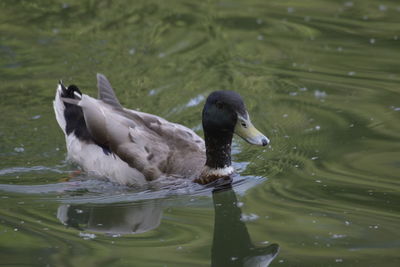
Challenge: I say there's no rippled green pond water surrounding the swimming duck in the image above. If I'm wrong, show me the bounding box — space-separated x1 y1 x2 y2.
0 0 400 266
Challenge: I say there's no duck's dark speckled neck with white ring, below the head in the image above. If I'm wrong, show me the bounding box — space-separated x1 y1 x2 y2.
196 132 233 184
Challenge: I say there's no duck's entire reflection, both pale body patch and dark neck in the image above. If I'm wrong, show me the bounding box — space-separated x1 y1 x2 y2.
57 183 279 267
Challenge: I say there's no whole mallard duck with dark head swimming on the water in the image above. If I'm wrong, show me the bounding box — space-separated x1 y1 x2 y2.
53 73 270 186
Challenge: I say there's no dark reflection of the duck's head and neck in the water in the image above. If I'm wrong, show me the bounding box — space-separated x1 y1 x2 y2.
211 184 279 267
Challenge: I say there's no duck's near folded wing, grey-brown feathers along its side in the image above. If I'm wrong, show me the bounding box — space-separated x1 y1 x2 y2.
67 94 170 180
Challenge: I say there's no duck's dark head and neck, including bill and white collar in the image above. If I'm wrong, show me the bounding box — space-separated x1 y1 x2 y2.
198 91 270 183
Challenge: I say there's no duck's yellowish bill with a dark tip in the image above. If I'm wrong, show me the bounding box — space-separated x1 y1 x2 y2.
235 117 270 146
